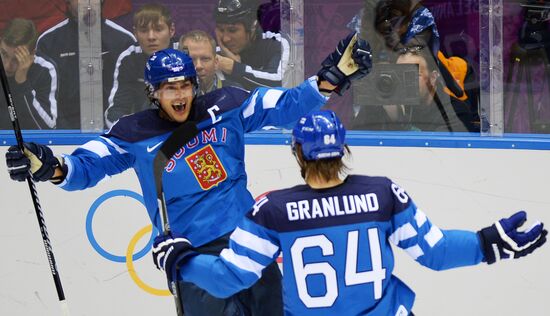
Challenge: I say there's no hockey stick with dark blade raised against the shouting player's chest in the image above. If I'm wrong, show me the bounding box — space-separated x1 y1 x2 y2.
153 121 198 316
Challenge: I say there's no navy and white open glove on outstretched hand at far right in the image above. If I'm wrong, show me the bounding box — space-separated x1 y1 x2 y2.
478 211 548 264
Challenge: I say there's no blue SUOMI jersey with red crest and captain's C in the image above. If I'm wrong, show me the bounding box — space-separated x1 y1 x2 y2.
60 77 327 246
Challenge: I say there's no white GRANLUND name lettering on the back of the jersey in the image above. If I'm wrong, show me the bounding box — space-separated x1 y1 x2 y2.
286 193 380 221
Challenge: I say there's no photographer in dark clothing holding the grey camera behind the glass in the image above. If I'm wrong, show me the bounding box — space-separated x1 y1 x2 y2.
353 46 479 132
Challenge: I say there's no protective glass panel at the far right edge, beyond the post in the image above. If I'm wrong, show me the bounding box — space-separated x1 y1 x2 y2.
502 0 550 134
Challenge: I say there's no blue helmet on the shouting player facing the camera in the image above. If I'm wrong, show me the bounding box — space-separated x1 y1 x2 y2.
144 48 198 91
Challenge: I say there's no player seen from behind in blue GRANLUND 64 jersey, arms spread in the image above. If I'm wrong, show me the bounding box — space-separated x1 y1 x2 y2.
153 111 548 316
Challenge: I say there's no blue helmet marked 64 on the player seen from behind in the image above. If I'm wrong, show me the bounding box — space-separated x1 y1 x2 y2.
292 110 346 160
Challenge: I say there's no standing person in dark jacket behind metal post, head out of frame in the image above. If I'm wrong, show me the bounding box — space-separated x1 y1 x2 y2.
37 0 135 129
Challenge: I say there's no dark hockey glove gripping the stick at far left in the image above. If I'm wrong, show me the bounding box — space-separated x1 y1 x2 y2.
6 143 60 181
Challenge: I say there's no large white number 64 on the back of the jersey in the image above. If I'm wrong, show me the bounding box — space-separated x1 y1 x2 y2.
290 228 386 308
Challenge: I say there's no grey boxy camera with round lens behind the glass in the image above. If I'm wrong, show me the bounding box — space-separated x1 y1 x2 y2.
353 64 420 106
